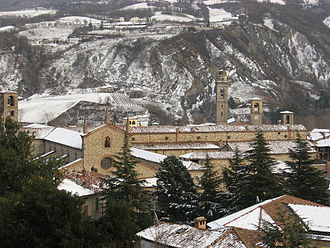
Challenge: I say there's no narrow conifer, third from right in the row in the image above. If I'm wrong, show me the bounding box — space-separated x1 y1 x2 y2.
222 148 248 214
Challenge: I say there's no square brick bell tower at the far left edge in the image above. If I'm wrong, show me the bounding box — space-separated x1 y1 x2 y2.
0 91 18 122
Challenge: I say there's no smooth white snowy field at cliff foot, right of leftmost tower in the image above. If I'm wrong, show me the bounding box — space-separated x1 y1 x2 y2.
18 93 136 123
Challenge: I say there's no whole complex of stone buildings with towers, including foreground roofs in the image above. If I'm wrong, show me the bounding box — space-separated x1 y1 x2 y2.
0 71 330 247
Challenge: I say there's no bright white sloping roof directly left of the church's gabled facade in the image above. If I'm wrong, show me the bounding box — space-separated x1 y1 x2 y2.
44 127 82 149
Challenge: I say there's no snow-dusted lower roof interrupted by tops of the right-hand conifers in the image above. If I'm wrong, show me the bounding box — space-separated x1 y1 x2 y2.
228 140 315 154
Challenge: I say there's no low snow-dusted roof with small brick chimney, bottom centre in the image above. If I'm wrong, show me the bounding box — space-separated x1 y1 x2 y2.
136 223 232 248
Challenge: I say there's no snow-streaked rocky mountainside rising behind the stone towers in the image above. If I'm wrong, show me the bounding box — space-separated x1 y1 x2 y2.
0 0 330 126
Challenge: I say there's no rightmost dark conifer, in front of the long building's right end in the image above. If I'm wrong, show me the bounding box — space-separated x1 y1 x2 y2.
284 136 329 204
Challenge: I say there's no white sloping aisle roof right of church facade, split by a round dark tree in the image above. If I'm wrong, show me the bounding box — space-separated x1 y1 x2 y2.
131 147 203 170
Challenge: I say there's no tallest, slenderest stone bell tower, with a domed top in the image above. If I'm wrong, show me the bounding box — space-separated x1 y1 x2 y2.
216 70 229 125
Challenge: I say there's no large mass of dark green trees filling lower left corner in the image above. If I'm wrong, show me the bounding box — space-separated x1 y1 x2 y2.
0 119 98 248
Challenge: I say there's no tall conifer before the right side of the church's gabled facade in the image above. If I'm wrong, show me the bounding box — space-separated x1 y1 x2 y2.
104 128 151 231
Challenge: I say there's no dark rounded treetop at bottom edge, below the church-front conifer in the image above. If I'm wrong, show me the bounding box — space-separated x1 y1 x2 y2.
97 200 139 248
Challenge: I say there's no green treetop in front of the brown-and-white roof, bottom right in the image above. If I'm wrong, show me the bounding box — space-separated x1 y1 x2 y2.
259 207 316 248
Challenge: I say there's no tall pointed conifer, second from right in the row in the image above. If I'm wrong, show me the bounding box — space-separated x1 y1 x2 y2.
242 132 282 207
